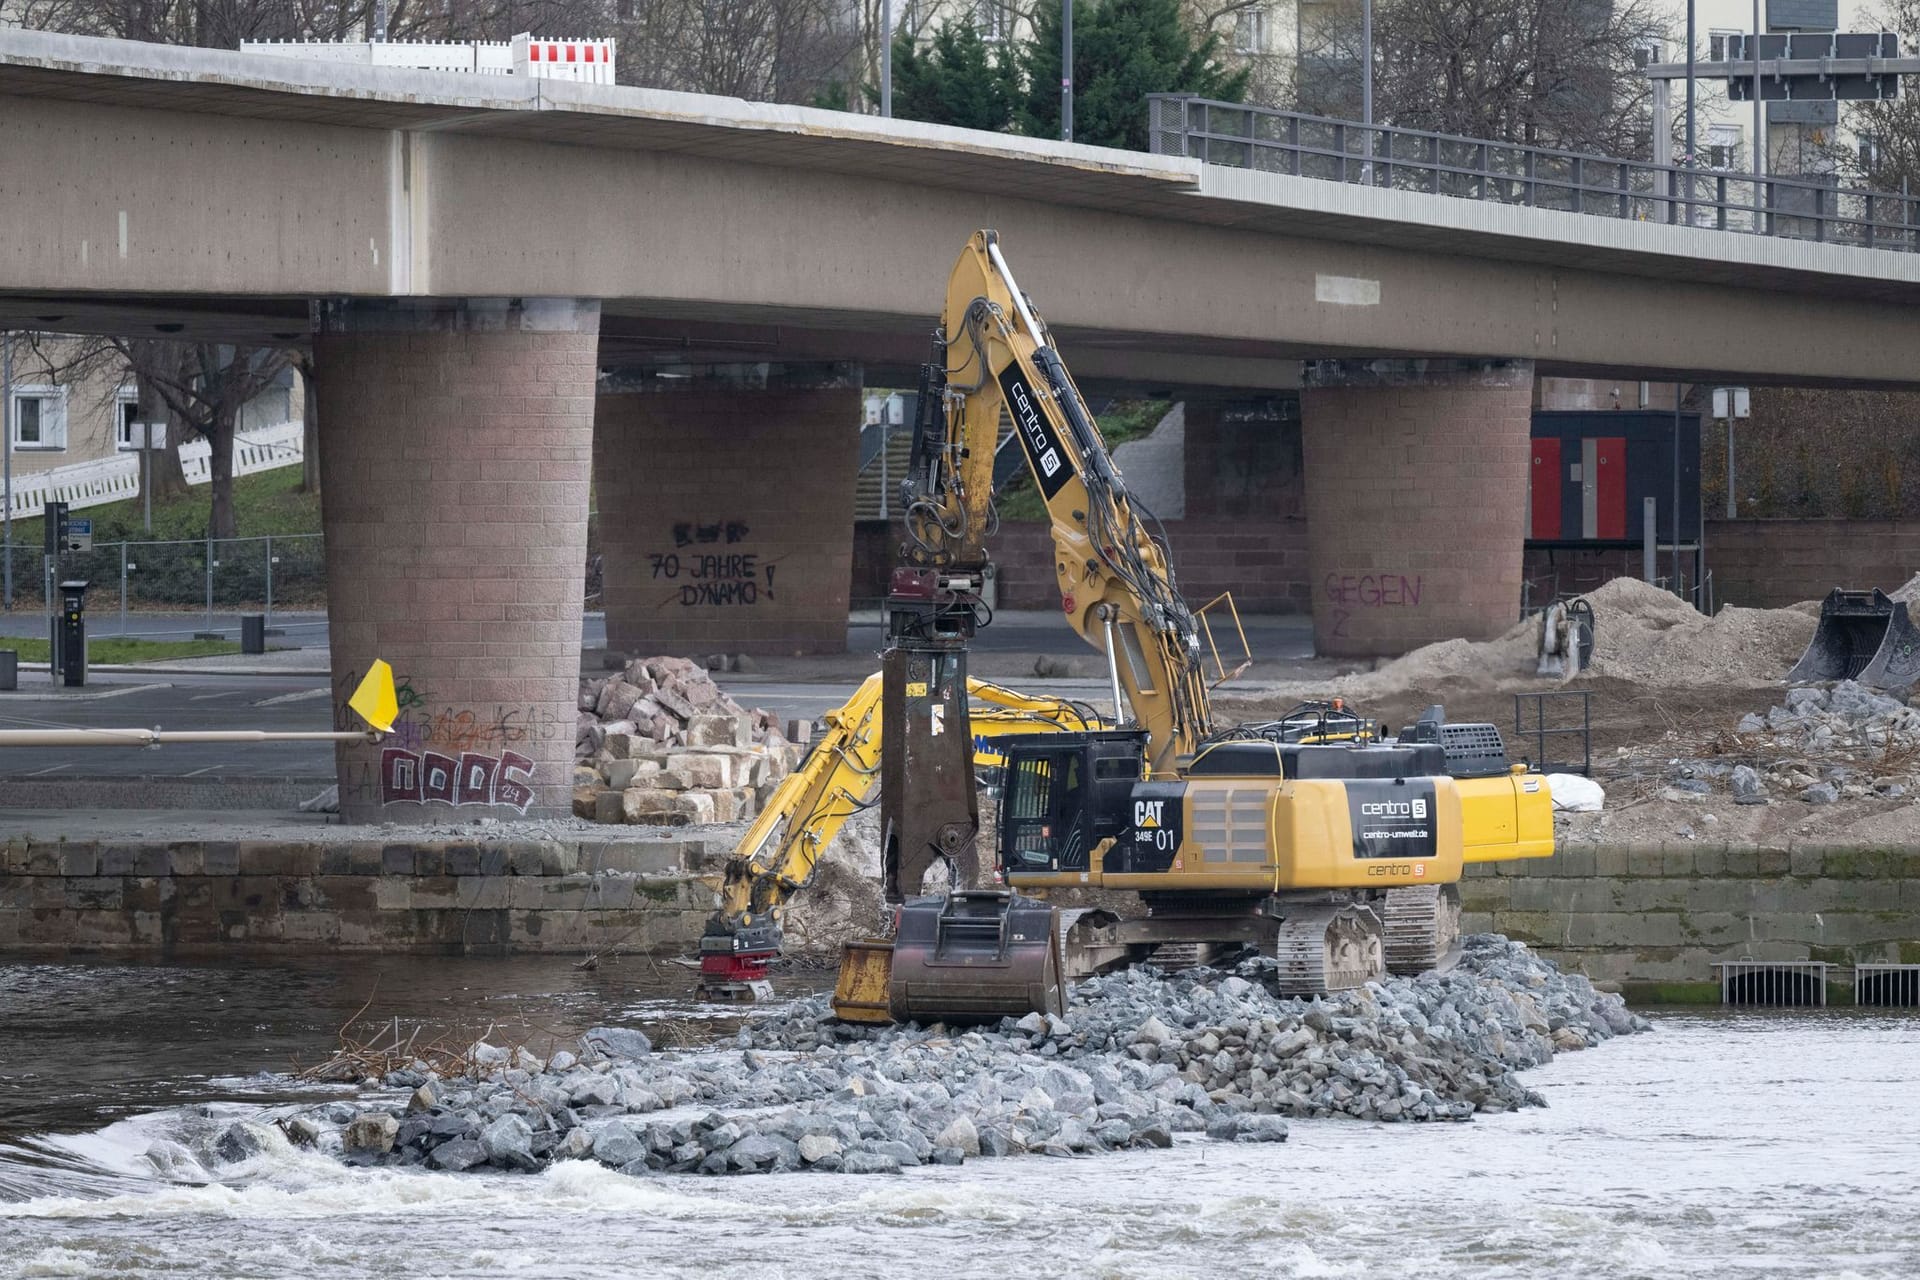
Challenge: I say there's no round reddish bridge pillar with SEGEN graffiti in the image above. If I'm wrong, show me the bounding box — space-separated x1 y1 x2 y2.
1300 359 1534 658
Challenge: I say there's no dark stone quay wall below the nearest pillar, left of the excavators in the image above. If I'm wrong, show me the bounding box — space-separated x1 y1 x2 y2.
0 831 735 952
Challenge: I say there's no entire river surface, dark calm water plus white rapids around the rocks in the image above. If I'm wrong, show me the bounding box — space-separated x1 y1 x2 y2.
0 958 1920 1280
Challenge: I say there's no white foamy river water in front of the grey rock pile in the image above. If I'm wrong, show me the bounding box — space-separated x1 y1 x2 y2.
0 1013 1920 1280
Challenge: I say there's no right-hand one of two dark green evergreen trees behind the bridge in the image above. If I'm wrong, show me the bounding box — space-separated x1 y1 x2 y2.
1020 0 1248 152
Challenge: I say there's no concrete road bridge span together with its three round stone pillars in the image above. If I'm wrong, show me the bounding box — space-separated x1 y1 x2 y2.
11 31 1920 821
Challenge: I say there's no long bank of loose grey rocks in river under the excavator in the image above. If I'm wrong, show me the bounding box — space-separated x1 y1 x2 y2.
263 935 1647 1174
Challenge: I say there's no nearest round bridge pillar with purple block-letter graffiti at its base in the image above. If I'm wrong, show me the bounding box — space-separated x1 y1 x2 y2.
313 297 599 823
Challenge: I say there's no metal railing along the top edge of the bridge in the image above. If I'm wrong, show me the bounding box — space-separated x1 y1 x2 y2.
1148 94 1920 253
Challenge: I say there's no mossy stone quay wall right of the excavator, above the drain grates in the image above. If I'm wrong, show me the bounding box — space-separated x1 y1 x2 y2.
1461 842 1920 984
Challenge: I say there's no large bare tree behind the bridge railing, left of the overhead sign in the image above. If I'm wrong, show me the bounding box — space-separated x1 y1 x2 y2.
1300 0 1667 155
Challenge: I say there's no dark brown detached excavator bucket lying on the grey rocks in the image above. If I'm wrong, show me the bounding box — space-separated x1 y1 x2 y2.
887 889 1066 1023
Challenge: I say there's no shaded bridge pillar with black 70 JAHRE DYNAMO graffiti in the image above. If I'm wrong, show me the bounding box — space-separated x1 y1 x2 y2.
593 363 862 656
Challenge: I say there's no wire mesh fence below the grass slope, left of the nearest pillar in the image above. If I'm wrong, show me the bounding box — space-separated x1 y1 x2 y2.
0 533 326 635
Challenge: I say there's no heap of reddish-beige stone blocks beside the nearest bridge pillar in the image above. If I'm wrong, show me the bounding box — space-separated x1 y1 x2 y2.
574 658 804 827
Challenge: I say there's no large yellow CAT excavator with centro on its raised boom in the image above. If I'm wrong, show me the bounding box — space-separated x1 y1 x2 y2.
698 230 1553 1021
